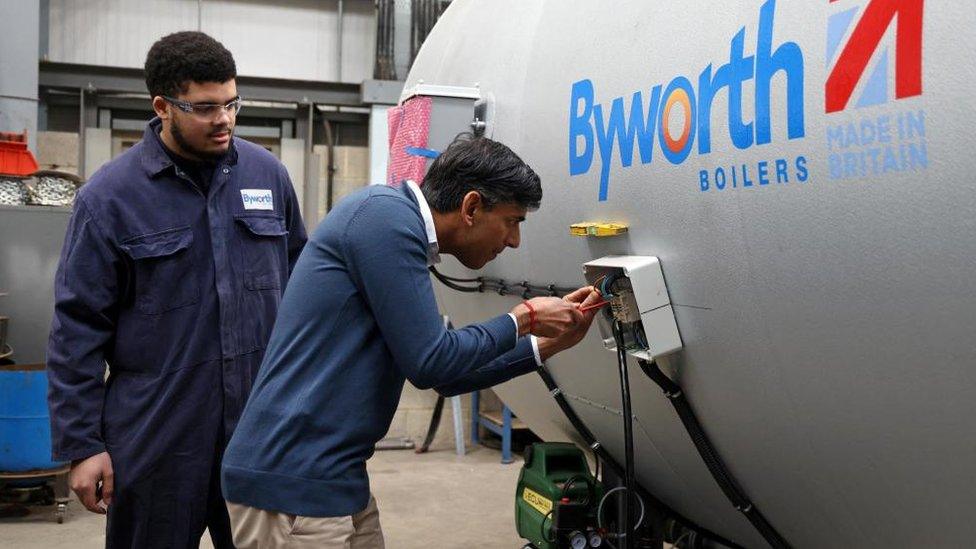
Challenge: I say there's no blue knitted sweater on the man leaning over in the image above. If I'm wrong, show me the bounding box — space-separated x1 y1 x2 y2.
221 185 536 517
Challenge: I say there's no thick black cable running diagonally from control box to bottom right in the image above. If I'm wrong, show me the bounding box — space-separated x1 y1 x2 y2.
637 359 790 549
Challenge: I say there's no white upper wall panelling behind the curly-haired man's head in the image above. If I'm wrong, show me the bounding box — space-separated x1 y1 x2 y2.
48 0 376 82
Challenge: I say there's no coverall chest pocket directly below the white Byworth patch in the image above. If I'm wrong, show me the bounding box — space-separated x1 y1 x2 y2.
235 213 288 290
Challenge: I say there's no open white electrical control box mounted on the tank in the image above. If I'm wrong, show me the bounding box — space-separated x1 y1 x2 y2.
583 255 682 360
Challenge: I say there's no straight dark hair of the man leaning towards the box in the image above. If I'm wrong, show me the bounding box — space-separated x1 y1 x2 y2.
421 134 542 213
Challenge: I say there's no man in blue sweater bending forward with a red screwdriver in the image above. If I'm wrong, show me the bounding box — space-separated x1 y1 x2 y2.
222 138 600 549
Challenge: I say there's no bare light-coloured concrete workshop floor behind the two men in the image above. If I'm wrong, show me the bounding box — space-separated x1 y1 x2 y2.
0 447 522 549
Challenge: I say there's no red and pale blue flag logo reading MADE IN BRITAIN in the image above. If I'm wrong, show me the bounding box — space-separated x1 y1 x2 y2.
824 0 928 180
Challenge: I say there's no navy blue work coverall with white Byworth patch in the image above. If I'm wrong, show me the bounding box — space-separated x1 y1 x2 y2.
47 119 306 549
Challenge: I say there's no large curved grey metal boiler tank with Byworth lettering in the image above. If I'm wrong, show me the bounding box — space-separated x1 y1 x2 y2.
407 0 976 547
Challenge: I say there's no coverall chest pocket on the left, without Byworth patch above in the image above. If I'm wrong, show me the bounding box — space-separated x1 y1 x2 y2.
120 227 200 315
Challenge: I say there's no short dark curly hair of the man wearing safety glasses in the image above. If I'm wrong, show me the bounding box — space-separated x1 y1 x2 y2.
146 31 237 97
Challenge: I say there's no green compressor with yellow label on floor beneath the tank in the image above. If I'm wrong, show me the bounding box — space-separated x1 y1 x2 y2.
515 442 606 549
